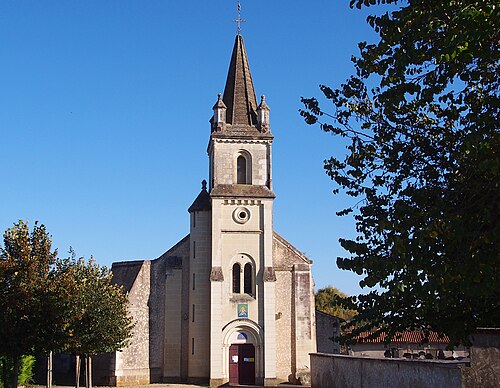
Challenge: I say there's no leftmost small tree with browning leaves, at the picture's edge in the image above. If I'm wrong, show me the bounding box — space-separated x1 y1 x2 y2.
0 221 57 387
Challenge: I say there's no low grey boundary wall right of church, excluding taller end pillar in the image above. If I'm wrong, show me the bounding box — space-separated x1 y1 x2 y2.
310 353 468 388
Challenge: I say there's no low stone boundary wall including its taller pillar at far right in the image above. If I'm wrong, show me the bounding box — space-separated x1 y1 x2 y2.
310 328 500 388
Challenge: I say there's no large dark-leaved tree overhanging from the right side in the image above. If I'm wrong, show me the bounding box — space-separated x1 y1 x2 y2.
301 0 500 343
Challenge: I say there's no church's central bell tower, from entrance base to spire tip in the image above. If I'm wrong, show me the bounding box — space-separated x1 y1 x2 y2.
208 33 276 386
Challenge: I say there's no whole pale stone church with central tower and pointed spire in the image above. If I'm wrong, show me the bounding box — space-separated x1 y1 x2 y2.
94 33 316 387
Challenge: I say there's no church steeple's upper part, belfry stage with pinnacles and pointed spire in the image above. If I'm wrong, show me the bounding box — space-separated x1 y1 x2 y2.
207 34 274 194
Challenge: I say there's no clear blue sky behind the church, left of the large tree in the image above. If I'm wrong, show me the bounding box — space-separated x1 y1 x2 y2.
0 0 380 294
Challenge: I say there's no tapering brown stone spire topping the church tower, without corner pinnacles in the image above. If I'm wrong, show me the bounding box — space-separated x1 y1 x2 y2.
223 35 258 127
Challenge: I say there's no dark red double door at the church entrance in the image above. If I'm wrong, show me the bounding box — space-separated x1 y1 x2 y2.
229 344 255 385
